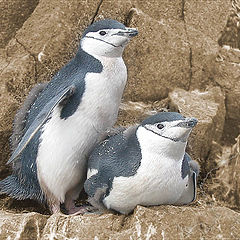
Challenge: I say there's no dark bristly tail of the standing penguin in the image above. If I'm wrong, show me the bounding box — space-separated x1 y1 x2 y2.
0 175 44 202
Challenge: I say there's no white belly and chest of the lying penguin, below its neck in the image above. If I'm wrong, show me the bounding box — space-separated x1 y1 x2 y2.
103 156 188 214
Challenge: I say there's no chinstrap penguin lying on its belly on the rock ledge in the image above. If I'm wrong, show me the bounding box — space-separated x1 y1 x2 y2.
84 112 199 214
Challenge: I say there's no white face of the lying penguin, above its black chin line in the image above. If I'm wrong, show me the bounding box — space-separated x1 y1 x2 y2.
144 119 196 143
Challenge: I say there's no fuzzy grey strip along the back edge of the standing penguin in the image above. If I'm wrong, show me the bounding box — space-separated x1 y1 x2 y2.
10 82 48 151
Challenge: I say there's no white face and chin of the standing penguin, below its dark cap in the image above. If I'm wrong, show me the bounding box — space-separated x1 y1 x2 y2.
81 28 137 57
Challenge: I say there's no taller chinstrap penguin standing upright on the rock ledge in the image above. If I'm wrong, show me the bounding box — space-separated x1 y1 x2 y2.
0 19 138 214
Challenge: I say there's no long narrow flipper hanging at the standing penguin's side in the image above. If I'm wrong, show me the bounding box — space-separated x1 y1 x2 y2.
7 85 76 164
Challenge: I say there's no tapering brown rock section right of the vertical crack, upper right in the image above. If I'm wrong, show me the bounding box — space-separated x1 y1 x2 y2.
183 0 231 90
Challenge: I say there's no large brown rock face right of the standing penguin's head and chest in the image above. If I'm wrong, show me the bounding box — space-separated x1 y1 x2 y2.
94 0 231 101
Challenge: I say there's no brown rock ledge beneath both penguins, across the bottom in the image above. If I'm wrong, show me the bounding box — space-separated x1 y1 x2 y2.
0 206 240 240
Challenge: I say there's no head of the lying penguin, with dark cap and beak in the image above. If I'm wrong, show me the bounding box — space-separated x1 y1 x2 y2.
141 112 198 143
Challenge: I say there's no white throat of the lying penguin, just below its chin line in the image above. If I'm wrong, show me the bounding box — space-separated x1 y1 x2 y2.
137 127 187 161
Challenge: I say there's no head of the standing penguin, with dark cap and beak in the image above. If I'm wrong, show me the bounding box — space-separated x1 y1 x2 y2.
80 19 138 57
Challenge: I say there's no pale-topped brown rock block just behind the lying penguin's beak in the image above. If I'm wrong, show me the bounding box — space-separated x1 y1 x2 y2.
169 87 225 174
